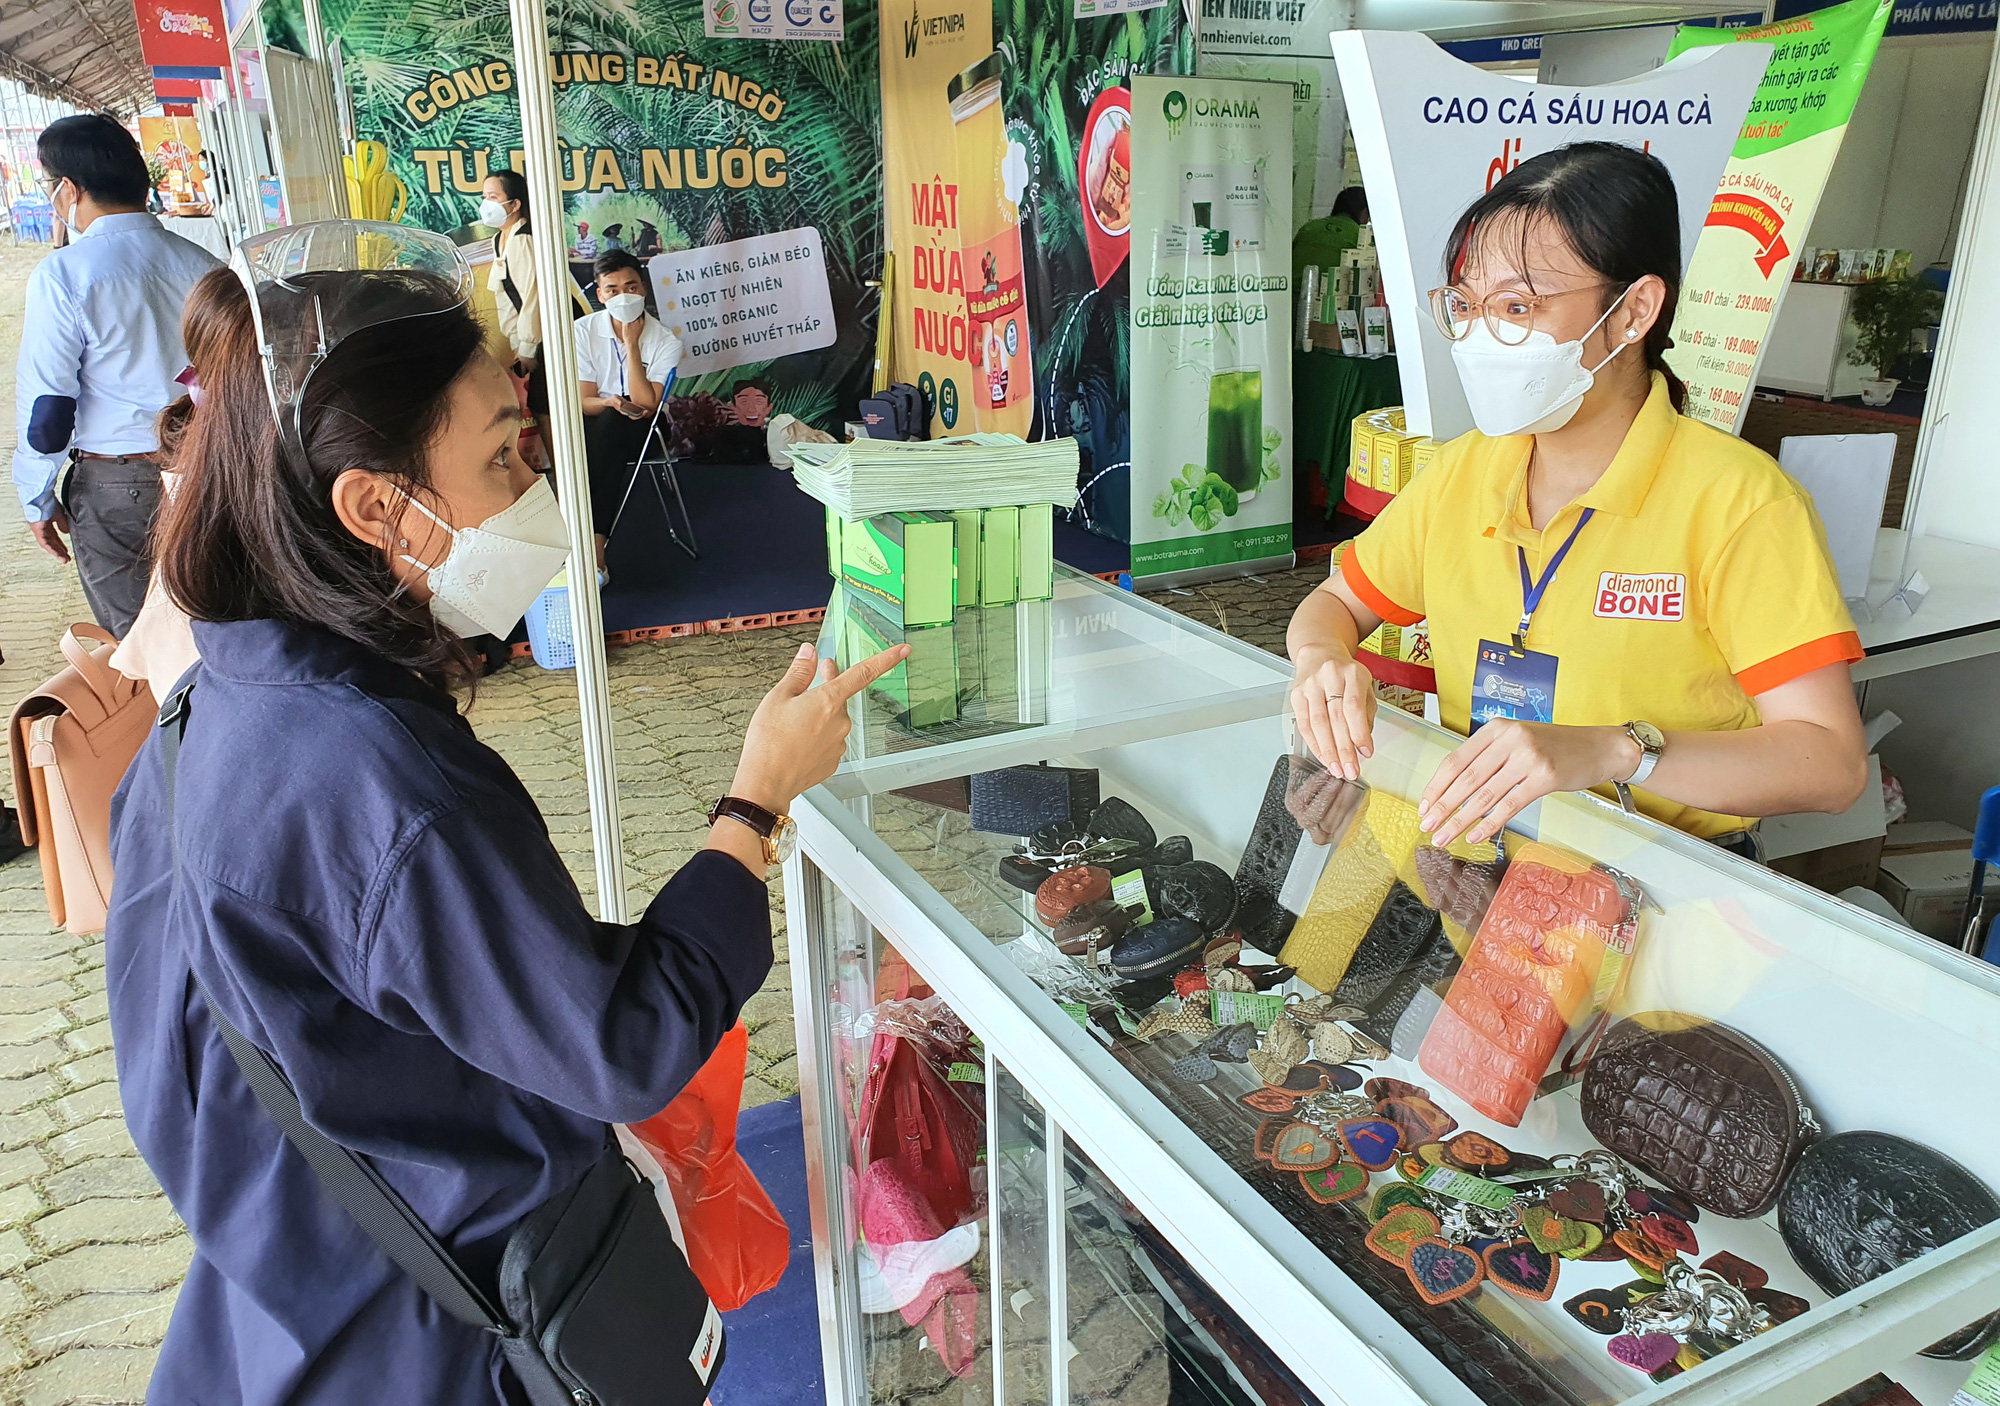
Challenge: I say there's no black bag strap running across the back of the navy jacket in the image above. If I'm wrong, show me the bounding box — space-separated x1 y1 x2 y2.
160 678 512 1336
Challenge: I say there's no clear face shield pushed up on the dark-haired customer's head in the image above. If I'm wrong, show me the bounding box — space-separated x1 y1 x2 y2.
230 220 472 464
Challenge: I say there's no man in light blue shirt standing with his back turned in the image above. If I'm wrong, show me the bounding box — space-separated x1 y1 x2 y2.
14 114 220 638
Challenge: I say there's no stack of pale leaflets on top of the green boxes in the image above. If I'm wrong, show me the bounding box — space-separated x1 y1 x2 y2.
790 434 1076 522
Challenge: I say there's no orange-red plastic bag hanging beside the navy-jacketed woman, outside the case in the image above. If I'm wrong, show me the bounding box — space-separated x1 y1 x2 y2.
632 1020 792 1312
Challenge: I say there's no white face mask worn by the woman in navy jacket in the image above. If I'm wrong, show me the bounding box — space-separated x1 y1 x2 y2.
402 478 570 638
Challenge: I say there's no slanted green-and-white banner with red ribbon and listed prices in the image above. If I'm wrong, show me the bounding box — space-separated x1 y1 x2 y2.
1666 0 1892 434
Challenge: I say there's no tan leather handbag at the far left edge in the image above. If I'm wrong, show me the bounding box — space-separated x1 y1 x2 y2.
8 624 156 934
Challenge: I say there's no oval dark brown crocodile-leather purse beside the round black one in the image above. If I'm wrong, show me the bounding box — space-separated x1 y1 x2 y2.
1582 1010 1820 1218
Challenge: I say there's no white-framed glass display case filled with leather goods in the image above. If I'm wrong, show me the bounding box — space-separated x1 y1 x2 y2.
786 572 2000 1406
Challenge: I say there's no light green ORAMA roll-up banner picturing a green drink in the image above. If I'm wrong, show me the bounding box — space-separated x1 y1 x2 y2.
1132 78 1292 584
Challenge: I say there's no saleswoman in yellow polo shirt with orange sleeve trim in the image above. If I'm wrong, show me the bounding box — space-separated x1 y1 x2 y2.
1288 142 1866 848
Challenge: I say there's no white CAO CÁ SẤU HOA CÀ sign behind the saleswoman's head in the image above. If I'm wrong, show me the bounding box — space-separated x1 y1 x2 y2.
1332 30 1770 444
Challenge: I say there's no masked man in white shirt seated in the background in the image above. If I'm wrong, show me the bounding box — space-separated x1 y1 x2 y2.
572 250 680 568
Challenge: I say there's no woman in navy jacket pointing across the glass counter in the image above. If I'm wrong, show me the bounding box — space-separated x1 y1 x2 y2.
104 256 900 1406
